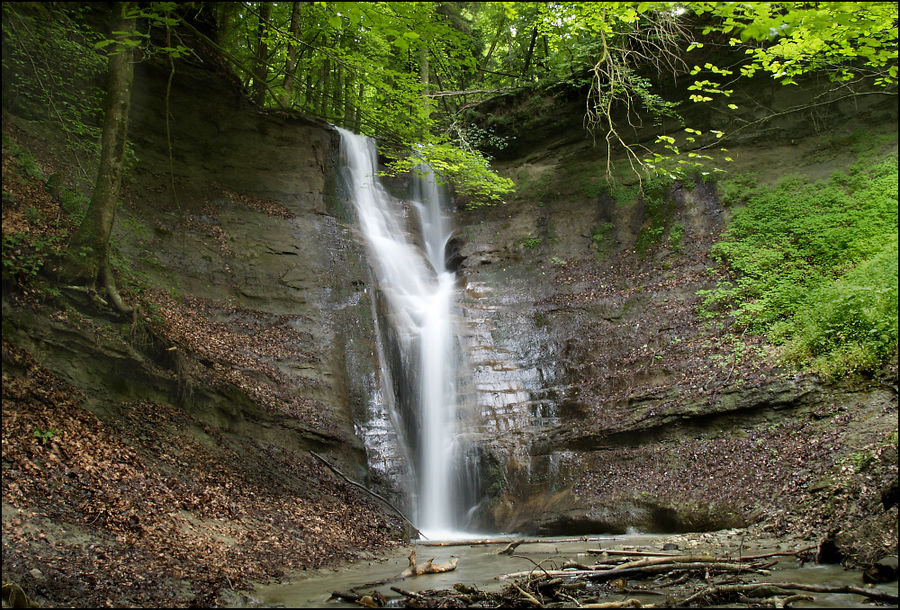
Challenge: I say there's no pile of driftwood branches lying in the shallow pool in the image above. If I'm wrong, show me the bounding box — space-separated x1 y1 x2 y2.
334 541 897 608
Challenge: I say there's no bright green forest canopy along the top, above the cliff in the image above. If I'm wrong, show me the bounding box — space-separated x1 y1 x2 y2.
3 2 897 205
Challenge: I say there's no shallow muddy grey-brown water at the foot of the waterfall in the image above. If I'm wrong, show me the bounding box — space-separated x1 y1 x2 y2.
243 530 897 608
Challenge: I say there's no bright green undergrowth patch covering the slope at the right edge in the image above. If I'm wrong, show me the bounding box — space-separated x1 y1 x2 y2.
698 147 898 377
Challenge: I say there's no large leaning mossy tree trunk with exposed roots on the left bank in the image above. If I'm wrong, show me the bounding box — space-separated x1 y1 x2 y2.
62 2 135 311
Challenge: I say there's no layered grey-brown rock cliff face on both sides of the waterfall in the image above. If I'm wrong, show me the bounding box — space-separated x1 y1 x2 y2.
118 54 896 560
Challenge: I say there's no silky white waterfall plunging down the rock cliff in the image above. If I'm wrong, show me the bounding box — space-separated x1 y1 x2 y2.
338 128 477 538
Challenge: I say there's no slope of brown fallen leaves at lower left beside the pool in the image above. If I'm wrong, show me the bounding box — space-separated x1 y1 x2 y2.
3 341 399 606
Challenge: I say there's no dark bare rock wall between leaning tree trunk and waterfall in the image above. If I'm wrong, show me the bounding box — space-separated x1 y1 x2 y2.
5 52 384 479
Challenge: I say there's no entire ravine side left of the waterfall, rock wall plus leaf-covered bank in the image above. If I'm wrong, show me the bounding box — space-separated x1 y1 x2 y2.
3 54 404 606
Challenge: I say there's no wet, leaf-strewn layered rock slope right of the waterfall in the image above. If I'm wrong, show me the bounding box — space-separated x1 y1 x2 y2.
460 86 897 563
